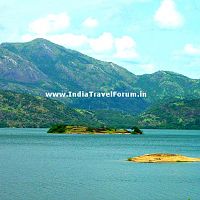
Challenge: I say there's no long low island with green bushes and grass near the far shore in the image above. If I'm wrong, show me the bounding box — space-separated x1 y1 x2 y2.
48 125 142 134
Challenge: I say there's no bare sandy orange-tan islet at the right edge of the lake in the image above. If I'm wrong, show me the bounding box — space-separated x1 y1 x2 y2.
128 153 200 163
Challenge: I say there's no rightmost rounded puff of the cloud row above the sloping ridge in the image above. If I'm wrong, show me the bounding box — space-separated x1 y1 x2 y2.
114 36 138 59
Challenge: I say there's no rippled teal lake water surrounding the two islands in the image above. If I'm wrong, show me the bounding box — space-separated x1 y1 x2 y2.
0 129 200 200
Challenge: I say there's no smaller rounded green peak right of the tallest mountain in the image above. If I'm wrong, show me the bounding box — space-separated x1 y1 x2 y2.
135 71 200 104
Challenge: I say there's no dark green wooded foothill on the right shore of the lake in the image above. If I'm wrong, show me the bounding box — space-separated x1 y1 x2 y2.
135 99 200 129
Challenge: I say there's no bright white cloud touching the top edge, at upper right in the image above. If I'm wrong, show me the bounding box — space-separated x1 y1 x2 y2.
154 0 183 28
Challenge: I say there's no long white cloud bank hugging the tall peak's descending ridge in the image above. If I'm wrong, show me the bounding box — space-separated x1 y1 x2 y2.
22 22 139 60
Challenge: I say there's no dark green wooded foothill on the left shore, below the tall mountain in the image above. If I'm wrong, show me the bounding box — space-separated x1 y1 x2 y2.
0 90 102 127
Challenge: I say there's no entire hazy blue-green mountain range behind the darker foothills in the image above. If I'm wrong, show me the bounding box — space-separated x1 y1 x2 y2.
0 39 200 114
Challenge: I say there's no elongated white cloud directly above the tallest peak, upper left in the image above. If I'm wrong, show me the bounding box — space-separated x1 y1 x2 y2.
29 13 70 35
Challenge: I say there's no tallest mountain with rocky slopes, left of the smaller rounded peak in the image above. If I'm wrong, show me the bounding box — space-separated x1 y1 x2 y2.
0 39 147 112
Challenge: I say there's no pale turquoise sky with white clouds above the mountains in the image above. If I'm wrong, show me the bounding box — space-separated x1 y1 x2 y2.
0 0 200 79
